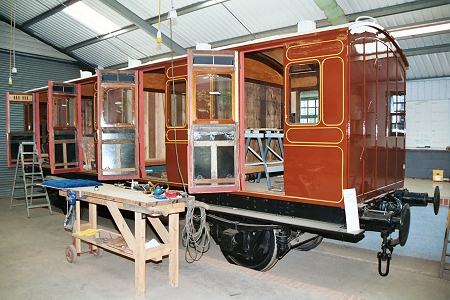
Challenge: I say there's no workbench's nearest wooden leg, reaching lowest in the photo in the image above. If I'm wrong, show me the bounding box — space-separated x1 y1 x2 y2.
134 212 146 296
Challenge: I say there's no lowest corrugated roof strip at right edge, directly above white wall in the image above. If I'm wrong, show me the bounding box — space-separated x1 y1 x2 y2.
407 52 450 79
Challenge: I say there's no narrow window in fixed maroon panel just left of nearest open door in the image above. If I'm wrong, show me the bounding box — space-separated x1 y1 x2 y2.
167 79 186 127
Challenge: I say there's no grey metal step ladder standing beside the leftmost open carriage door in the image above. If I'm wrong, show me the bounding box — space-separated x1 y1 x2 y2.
10 142 53 218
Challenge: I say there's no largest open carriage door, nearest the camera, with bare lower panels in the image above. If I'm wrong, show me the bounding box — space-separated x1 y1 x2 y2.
188 51 239 193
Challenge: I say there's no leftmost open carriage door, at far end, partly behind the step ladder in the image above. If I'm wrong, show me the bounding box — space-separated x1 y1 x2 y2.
6 93 33 167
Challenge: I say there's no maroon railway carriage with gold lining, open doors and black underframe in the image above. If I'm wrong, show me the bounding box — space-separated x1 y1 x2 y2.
7 22 439 275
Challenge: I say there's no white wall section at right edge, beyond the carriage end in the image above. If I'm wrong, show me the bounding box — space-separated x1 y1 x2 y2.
406 77 450 149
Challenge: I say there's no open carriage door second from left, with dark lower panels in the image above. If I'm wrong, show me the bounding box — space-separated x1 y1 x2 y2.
47 81 83 174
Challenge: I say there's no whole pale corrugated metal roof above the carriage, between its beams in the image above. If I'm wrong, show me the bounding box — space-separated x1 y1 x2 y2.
0 0 450 78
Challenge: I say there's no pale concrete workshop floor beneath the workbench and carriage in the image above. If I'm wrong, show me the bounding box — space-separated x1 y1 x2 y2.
0 179 450 300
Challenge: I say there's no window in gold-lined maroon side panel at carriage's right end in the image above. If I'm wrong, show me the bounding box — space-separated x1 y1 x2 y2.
289 62 320 124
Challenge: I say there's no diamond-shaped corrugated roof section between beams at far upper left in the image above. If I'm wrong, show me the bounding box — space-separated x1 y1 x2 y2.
30 12 97 47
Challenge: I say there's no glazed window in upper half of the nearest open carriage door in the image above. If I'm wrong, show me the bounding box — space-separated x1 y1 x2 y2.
195 74 233 120
